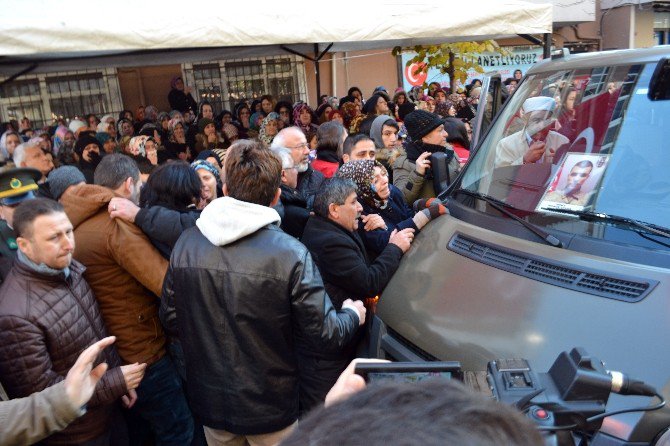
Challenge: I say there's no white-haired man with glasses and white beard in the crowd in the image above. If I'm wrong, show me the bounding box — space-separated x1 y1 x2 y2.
271 127 325 210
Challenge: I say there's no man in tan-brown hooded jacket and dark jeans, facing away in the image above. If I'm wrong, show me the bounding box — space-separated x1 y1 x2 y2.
61 154 193 445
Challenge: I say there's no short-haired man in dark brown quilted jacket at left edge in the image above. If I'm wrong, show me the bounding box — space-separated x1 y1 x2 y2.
0 198 146 445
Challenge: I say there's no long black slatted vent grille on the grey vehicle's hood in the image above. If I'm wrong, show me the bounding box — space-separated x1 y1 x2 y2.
447 234 658 302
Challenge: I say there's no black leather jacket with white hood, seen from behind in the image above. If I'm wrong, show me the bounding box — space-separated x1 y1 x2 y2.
163 197 358 435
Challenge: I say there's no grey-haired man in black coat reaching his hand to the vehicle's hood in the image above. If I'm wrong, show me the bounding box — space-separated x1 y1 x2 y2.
299 177 414 413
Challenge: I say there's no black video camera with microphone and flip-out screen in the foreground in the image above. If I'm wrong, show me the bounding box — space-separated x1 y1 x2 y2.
356 347 665 445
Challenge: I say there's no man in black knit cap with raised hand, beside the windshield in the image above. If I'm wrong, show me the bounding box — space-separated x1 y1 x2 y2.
393 110 460 204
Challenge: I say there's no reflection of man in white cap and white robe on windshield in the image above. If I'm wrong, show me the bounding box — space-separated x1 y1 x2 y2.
495 96 570 167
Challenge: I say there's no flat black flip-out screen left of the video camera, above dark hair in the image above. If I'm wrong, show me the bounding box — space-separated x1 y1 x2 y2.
355 361 462 383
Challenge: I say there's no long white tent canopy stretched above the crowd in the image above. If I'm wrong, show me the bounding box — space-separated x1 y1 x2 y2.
0 0 553 75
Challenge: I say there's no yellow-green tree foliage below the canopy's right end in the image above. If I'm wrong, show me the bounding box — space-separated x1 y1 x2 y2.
404 40 509 90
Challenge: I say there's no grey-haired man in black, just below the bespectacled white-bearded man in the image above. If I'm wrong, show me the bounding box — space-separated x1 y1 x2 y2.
272 148 309 240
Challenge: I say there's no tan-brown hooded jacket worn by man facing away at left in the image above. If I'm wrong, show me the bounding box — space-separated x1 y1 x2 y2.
61 184 167 365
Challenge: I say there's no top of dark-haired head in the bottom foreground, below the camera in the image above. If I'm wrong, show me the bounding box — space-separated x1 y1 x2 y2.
282 379 543 446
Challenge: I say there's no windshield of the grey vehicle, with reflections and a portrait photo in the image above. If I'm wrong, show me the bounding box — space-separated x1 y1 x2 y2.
460 63 670 247
